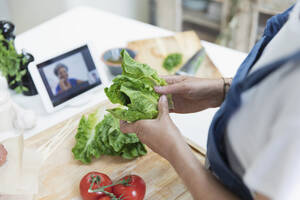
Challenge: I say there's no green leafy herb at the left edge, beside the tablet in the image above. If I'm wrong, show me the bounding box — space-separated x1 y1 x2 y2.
0 32 28 93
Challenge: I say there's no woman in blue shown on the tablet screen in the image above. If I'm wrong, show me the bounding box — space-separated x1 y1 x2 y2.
54 63 83 94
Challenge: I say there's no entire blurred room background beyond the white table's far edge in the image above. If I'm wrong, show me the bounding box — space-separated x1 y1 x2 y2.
0 0 296 52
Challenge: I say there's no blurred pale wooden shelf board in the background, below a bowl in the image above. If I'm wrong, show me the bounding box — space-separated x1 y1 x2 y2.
182 8 221 31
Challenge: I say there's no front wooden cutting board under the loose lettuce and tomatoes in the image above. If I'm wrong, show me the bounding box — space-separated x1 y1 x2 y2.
25 101 204 200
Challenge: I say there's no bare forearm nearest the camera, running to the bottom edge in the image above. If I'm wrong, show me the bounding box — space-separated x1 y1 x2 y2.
168 141 238 200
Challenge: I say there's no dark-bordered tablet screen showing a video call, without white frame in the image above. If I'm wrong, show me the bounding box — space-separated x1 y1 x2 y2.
37 45 101 107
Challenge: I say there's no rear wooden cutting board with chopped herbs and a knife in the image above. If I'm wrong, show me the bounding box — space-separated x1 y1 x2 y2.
127 31 222 78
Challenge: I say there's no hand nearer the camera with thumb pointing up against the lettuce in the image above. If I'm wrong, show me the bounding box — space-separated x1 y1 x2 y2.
120 95 186 160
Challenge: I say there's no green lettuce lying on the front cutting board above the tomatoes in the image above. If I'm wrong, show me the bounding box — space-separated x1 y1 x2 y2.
72 112 147 164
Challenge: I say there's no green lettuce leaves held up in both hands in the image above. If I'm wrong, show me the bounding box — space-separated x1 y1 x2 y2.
105 50 172 122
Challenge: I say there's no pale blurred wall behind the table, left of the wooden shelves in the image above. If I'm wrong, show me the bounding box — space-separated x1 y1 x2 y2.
4 0 150 33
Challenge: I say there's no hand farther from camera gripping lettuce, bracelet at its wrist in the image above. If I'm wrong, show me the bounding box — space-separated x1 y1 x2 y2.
155 76 224 113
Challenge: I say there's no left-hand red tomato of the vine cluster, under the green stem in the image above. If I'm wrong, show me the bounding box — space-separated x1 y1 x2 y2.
80 172 112 200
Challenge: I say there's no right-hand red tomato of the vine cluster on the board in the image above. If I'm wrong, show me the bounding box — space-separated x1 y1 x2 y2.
113 175 146 200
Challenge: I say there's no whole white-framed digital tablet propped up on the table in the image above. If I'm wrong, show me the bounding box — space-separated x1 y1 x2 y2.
29 44 107 112
